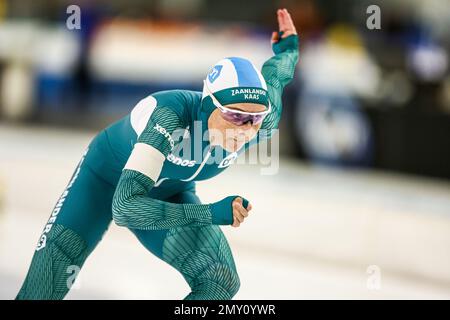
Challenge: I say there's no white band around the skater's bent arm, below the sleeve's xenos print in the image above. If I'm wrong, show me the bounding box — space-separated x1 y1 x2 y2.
124 142 166 182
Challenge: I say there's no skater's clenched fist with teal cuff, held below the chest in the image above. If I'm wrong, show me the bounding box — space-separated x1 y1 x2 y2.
210 196 252 227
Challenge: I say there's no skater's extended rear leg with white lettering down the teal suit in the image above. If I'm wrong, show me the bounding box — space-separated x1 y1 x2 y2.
16 150 114 300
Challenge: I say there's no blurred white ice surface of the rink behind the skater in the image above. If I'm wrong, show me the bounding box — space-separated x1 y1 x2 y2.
0 125 450 299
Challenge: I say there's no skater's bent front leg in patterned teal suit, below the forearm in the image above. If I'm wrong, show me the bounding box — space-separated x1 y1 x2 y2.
133 191 240 300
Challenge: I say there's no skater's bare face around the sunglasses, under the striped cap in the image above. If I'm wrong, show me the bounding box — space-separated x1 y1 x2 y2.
208 103 266 152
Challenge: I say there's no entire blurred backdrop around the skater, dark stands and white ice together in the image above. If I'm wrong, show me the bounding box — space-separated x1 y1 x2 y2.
0 0 450 299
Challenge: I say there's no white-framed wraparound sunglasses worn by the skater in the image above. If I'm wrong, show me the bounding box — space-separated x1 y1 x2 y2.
203 80 272 126
